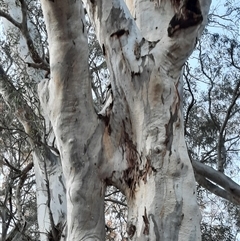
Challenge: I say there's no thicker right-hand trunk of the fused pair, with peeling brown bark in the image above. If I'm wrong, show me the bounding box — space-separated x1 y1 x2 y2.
85 1 210 240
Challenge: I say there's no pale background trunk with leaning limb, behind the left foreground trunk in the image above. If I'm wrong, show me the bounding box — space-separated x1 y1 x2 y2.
0 0 66 241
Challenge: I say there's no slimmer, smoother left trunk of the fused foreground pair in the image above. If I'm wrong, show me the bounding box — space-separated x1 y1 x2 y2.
39 1 105 240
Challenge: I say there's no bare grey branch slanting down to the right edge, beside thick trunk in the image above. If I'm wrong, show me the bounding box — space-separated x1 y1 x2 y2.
192 160 240 204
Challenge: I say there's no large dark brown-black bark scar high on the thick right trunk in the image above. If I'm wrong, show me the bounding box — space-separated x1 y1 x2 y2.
167 0 203 37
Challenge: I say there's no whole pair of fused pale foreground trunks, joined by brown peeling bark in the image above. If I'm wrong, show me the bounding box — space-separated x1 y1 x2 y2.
42 0 210 241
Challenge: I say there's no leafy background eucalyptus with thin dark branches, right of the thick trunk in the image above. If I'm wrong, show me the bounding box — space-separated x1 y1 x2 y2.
184 1 240 240
